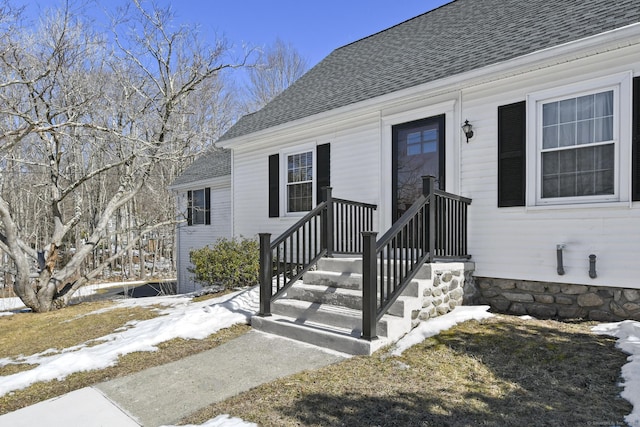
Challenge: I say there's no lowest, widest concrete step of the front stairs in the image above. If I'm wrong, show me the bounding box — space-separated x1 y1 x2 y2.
251 315 391 355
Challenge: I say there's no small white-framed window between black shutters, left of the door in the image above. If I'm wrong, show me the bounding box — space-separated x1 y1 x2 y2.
281 147 316 214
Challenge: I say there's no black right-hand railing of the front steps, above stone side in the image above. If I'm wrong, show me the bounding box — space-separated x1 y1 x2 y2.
362 177 471 340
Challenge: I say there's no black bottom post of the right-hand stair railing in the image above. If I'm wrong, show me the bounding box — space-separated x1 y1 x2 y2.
362 231 378 341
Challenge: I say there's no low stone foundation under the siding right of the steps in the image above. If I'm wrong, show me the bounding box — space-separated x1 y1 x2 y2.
472 277 640 321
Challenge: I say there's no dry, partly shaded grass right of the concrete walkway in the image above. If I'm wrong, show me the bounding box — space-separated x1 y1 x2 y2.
183 316 632 427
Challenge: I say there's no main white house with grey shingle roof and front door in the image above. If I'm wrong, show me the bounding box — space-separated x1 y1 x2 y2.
218 0 640 328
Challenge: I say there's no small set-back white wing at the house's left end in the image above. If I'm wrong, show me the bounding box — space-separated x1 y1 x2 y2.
170 150 231 293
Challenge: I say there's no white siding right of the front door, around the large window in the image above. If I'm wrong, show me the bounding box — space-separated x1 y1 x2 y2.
460 47 640 289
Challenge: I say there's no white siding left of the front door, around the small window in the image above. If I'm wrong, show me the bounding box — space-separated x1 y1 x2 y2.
233 116 380 238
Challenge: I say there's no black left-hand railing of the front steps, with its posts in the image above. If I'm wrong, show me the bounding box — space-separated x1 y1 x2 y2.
259 187 377 316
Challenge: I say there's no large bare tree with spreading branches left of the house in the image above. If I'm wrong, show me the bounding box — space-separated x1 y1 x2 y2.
0 0 243 312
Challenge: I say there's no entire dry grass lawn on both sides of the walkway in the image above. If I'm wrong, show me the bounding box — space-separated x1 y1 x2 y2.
0 302 632 427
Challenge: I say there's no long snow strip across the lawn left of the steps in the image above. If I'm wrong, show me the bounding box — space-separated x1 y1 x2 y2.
0 287 259 396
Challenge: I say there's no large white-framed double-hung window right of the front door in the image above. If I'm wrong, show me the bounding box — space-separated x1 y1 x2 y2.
527 74 631 206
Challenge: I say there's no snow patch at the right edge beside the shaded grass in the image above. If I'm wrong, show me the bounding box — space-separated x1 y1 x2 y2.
592 320 640 427
